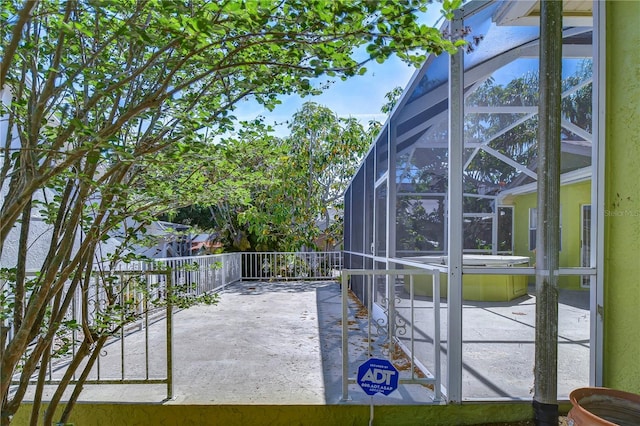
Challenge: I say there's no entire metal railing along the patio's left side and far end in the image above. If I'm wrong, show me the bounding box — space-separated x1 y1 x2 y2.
6 252 342 398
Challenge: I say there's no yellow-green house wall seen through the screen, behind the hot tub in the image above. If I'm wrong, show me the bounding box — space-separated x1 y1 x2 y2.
505 181 591 289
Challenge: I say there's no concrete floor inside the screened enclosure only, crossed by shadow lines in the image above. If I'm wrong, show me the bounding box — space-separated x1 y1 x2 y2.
396 287 590 400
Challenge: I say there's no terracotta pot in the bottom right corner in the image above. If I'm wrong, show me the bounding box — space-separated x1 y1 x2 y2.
568 387 640 426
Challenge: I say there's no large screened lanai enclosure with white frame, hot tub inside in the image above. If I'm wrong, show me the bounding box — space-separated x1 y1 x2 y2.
344 1 601 401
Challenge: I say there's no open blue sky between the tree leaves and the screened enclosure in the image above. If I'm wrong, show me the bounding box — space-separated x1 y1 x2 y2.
234 2 441 136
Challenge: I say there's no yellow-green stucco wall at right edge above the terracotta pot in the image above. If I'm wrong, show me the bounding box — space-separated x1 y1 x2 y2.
603 1 640 393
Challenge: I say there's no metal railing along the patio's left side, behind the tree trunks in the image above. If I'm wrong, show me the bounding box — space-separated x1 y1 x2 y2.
5 253 242 398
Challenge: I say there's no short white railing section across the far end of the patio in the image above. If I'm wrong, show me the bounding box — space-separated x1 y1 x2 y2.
242 251 342 281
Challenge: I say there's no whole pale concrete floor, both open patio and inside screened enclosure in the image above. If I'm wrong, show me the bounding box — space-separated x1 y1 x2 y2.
27 282 589 405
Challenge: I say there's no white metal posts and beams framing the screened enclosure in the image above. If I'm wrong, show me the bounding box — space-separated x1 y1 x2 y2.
342 0 606 402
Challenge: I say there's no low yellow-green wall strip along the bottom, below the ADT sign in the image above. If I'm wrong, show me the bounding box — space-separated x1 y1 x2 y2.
12 402 536 426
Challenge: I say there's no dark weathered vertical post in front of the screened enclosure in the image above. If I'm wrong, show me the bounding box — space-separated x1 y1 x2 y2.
533 0 562 425
